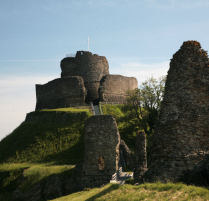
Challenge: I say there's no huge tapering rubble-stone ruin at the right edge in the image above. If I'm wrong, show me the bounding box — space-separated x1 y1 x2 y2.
144 41 209 181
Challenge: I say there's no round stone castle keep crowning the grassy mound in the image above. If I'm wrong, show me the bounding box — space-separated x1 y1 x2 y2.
36 51 138 110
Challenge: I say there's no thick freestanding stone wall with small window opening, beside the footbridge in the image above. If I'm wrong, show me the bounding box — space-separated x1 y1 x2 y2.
67 115 120 192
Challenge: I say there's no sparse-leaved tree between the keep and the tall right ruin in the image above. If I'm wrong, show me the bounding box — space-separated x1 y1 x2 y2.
124 76 166 135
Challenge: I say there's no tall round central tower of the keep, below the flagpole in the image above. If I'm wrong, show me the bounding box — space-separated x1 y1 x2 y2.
60 51 109 102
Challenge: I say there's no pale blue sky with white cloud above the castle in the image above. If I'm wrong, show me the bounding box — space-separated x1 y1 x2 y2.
0 0 209 139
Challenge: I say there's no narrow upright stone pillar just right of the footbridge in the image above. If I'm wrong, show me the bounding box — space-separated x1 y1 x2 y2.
134 131 147 183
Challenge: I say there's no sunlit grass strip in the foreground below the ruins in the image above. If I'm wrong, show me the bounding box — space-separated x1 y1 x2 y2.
53 182 209 201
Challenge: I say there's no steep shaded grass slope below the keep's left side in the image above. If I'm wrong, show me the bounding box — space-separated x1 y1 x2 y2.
0 108 92 164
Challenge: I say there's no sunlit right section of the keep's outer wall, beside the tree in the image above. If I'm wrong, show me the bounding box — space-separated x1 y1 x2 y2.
99 75 138 104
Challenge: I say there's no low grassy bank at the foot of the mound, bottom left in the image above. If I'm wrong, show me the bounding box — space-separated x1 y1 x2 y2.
0 163 74 201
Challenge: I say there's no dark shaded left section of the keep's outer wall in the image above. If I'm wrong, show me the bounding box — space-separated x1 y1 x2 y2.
36 76 86 110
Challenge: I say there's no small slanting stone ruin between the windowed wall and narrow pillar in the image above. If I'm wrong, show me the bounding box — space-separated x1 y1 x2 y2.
120 140 135 170
